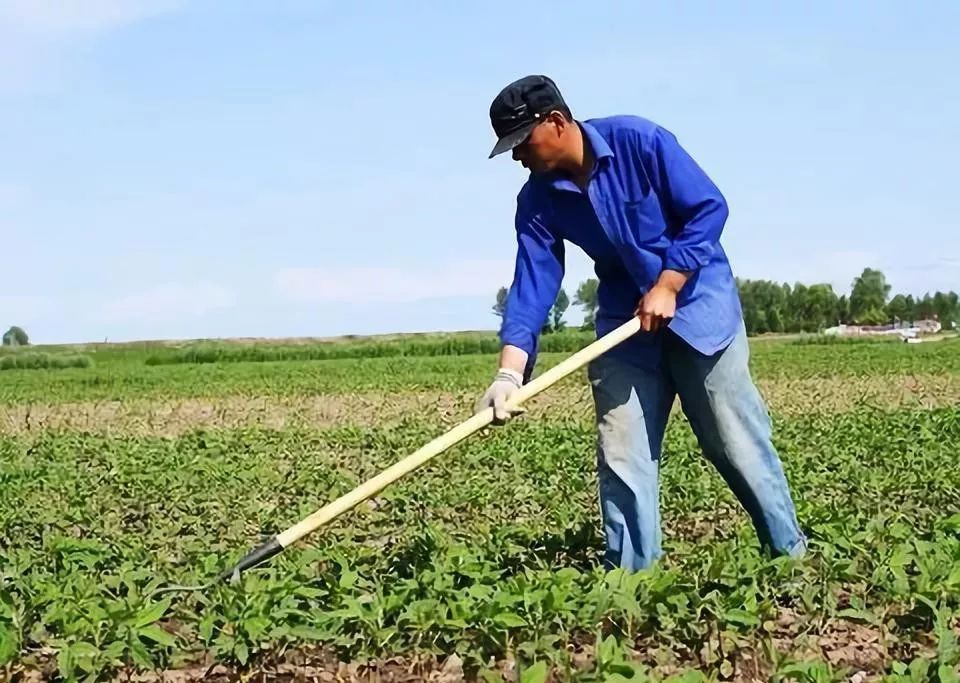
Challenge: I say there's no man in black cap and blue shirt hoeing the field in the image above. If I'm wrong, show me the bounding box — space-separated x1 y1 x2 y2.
476 76 806 571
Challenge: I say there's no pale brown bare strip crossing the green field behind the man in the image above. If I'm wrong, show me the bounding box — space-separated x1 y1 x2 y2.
0 374 960 436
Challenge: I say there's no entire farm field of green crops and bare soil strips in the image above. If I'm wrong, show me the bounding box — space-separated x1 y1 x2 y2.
0 340 960 683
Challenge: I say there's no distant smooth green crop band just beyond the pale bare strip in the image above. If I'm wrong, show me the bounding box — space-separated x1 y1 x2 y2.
0 341 960 404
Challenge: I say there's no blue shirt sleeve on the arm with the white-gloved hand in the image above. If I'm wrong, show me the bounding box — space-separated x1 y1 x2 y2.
500 190 564 378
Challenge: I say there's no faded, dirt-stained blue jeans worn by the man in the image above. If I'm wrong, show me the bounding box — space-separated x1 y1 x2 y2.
588 327 806 571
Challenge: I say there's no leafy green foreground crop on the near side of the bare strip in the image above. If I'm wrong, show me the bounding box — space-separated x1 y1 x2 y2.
0 409 960 680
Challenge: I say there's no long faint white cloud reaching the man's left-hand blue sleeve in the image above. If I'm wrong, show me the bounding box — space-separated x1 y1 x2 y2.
274 259 513 304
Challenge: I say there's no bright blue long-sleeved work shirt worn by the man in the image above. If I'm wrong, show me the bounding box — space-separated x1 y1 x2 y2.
500 116 743 379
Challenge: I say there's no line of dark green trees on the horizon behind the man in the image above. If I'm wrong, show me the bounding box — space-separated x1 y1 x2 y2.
493 268 960 335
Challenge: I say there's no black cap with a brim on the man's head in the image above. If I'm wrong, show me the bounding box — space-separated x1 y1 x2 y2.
487 75 566 159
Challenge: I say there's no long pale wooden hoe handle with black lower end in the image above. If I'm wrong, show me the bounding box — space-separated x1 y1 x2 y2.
221 317 640 580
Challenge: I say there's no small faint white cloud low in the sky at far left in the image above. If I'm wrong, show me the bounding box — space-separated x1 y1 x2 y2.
103 282 236 322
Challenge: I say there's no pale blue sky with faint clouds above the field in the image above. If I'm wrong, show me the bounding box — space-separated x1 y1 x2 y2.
0 0 960 343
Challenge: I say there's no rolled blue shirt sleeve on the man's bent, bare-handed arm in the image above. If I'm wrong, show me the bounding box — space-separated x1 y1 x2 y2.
647 127 729 272
